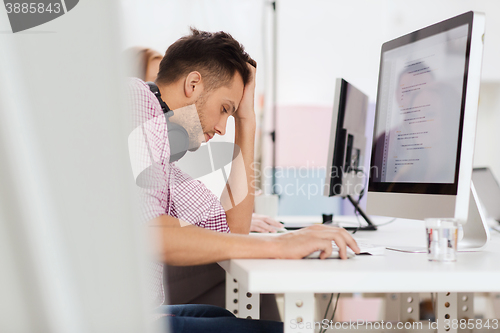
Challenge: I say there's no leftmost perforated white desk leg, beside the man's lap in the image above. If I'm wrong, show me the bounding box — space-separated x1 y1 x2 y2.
226 272 260 319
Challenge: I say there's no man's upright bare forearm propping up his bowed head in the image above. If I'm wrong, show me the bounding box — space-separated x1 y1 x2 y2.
221 118 255 234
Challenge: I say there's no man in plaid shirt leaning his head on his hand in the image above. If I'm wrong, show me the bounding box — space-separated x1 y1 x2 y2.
130 29 359 332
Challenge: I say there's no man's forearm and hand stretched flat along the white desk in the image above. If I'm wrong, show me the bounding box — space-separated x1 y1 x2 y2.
148 215 359 266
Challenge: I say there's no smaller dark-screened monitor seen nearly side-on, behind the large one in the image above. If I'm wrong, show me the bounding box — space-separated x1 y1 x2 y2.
323 78 376 230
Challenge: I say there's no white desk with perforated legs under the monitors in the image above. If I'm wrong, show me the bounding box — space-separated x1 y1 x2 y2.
219 219 500 333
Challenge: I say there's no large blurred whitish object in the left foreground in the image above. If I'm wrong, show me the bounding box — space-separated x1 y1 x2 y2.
0 0 158 333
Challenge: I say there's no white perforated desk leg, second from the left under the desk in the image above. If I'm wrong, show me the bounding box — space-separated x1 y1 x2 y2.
284 293 314 333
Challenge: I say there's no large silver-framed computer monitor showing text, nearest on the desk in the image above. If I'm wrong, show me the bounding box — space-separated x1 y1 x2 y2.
367 12 488 247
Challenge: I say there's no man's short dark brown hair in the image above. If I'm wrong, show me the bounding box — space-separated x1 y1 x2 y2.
156 28 256 90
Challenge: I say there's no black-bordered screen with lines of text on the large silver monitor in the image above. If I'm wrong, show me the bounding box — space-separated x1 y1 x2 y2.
370 16 471 194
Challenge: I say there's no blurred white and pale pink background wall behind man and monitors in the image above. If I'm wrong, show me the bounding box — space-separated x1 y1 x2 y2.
122 0 500 213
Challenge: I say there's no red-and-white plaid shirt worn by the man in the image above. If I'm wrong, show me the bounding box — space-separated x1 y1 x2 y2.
128 79 230 305
